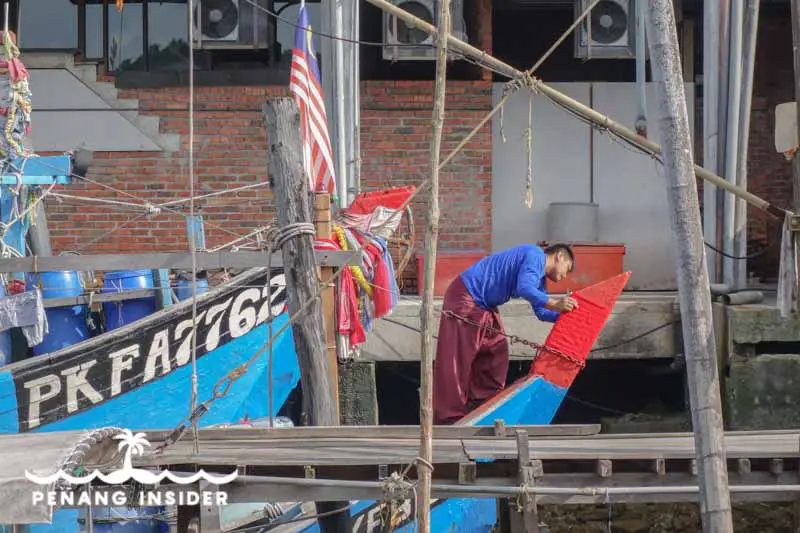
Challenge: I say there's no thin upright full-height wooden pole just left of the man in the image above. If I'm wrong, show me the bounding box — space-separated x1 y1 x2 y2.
417 0 450 533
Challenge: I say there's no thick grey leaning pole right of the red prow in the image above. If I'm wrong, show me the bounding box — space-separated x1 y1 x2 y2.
647 0 733 533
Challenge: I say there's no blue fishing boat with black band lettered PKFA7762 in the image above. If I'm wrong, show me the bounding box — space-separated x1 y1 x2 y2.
0 268 300 533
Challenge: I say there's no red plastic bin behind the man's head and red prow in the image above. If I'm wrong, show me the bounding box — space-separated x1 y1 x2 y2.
539 242 625 294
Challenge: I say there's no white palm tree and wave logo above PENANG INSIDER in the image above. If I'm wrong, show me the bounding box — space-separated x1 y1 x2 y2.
25 429 239 485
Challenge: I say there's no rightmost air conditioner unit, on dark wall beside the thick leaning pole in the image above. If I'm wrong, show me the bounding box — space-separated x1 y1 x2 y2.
574 0 636 59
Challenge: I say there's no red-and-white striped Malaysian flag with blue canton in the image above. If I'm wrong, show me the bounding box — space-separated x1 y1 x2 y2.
289 4 336 193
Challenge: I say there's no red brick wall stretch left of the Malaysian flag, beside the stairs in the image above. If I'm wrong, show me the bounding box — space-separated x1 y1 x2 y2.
47 87 284 253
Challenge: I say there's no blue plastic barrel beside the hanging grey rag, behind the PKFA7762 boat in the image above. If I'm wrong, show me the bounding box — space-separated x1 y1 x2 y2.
25 271 89 355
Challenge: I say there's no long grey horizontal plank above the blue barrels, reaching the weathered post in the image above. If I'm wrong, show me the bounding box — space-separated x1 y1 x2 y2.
0 251 352 273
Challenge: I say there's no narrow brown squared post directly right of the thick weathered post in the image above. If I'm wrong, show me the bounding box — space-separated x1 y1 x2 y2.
314 193 340 421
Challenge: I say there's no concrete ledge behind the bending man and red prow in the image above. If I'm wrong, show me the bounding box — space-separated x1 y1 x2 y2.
361 293 683 362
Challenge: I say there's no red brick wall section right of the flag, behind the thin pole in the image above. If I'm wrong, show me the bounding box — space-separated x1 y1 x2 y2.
361 81 492 289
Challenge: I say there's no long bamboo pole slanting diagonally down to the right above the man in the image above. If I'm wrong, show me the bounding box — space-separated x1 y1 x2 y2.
367 0 787 220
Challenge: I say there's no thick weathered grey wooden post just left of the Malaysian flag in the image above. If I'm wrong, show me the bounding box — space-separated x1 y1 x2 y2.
264 98 351 533
